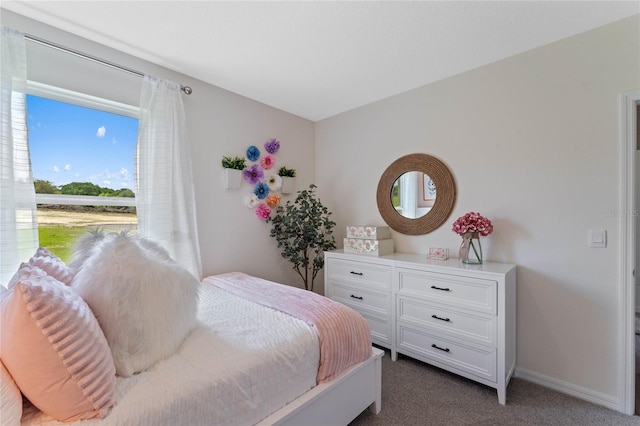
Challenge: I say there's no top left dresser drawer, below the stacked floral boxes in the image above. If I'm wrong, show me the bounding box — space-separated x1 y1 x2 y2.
327 259 391 291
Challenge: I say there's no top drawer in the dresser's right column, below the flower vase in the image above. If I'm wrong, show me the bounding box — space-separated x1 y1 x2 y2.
398 268 498 315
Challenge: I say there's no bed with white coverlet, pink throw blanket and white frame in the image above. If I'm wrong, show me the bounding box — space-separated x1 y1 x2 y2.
12 273 383 426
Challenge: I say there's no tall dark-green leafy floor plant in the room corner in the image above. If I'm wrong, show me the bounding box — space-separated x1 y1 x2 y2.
267 184 336 291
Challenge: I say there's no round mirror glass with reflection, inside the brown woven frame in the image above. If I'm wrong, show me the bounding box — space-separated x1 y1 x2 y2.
391 171 436 219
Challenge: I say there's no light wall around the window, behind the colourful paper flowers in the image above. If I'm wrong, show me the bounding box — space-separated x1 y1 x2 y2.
2 9 315 286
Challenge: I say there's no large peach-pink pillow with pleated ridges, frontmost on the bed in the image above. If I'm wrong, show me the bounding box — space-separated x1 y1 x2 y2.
0 266 116 421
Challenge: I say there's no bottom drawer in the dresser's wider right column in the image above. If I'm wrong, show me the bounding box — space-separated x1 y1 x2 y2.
397 325 497 382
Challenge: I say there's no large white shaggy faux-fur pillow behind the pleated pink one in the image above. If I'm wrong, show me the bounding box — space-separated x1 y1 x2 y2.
71 233 199 377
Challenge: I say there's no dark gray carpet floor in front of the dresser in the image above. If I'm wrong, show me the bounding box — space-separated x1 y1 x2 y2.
350 350 640 426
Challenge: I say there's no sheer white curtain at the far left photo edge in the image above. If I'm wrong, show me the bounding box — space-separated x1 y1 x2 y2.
0 27 38 286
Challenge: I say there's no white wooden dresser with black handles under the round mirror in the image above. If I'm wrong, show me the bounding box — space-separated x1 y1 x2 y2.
325 250 516 404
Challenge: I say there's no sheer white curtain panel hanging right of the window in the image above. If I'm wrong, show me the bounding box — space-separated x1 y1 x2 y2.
135 76 202 279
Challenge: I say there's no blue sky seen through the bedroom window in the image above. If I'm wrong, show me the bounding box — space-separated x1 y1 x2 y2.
27 95 138 190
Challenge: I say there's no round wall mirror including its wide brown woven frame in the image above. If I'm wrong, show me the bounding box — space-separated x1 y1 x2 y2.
377 154 456 235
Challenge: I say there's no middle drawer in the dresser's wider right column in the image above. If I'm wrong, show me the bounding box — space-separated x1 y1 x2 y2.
396 296 498 347
